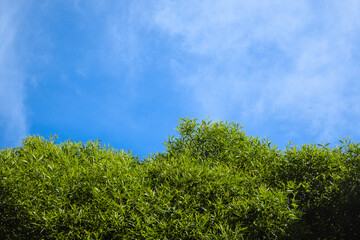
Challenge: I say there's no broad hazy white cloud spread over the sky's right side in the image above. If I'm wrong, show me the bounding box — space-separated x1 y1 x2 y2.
154 0 360 144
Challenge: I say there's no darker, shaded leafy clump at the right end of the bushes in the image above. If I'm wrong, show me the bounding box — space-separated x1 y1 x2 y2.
274 140 360 239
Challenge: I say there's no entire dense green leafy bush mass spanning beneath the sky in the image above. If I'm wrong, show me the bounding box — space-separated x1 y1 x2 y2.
0 119 360 239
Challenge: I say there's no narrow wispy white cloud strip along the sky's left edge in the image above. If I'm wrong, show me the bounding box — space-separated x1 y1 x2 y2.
0 0 28 147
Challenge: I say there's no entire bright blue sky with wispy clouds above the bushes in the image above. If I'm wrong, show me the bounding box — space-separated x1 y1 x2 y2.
0 0 360 156
